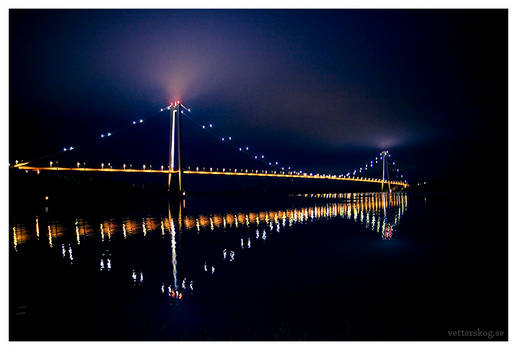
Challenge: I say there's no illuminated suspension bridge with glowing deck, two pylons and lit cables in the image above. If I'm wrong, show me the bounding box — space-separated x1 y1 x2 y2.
13 101 409 191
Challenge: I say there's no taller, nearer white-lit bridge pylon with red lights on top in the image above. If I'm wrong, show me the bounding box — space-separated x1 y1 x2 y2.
167 101 184 195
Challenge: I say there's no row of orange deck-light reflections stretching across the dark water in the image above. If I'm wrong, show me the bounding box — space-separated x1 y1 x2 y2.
15 194 407 245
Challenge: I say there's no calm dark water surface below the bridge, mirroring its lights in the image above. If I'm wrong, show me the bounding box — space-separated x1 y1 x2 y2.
10 193 507 340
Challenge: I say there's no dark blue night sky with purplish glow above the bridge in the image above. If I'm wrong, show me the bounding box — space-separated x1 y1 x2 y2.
9 10 508 180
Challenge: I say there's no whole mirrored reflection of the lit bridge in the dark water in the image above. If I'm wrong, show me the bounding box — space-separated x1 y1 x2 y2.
11 192 408 300
